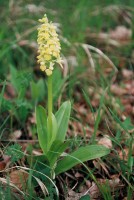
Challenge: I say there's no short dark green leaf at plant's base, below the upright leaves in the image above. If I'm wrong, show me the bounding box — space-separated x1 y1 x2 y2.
47 140 70 167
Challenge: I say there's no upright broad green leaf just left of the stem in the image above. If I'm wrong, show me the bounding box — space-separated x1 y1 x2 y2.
36 106 48 154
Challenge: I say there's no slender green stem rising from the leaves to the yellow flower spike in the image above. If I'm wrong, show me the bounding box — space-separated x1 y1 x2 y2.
48 75 53 134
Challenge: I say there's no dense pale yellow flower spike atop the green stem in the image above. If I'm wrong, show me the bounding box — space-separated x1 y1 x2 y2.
37 15 61 76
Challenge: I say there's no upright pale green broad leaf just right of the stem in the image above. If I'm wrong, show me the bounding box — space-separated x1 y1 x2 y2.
55 101 71 142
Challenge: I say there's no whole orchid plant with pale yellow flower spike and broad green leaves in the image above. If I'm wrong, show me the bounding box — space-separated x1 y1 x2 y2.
36 15 109 178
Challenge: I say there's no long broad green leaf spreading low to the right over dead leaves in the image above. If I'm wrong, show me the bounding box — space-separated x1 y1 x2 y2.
55 145 110 175
